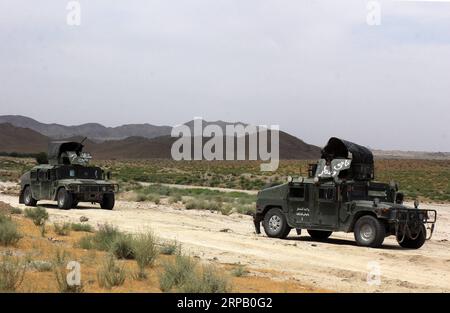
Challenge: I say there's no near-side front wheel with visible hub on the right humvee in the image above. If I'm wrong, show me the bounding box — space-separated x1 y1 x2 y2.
354 215 386 248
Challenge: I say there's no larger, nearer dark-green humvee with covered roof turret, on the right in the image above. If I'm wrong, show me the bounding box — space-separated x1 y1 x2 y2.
254 138 437 249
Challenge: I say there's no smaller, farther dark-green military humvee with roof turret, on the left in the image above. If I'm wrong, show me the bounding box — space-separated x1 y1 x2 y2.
19 142 119 210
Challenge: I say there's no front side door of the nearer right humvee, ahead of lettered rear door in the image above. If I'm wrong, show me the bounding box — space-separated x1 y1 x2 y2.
317 186 339 227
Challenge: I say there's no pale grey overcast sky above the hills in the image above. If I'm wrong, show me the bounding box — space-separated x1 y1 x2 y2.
0 0 450 151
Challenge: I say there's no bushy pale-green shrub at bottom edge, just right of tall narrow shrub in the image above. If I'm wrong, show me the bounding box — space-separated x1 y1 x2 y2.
159 254 197 292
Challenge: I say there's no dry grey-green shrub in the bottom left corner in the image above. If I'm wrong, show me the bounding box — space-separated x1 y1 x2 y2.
0 255 25 292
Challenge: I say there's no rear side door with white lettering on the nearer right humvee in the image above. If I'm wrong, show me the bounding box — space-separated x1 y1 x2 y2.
288 184 311 225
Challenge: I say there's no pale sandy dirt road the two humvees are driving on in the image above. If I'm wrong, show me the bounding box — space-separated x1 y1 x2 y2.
0 188 450 292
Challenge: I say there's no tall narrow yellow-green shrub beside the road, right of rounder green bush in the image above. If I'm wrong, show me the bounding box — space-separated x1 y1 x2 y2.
133 232 158 279
